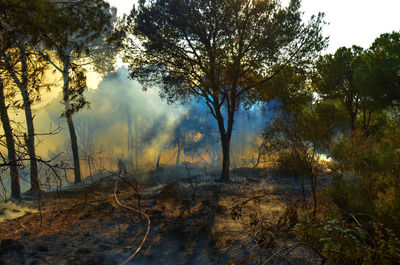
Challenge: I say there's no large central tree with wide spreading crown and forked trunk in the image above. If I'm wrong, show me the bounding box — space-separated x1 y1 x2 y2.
125 0 325 181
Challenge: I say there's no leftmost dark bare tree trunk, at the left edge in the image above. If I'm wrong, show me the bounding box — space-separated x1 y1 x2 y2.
0 80 21 200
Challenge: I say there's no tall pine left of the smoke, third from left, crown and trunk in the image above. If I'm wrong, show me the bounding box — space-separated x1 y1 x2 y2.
37 0 118 183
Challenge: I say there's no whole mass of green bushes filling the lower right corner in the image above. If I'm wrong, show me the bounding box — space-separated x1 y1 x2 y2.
297 113 400 264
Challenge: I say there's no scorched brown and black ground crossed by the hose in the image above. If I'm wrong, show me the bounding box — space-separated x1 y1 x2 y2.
0 169 324 265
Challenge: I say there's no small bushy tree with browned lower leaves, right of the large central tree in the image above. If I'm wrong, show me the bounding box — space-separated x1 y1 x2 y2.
263 94 342 214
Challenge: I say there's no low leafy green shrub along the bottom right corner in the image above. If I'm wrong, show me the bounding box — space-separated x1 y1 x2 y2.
296 218 400 265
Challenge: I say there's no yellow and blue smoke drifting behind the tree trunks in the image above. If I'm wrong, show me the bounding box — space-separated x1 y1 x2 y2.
3 68 280 194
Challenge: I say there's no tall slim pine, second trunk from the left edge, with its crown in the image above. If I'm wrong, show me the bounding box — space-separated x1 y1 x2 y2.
0 0 48 191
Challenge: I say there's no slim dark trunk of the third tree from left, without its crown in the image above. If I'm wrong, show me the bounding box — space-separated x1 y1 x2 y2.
63 55 82 183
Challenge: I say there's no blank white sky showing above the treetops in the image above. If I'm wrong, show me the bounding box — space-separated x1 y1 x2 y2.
108 0 400 53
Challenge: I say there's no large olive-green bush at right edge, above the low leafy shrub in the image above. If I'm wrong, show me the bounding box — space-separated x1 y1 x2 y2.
325 121 400 227
